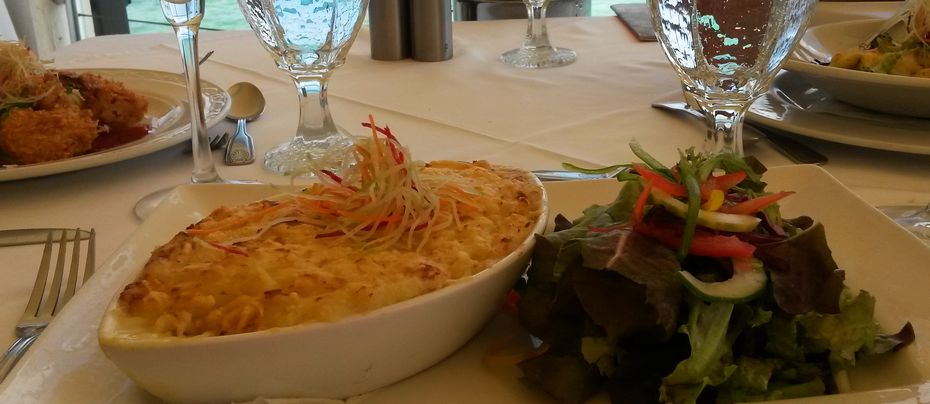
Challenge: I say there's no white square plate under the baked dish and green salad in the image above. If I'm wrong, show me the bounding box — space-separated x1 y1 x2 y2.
0 166 930 404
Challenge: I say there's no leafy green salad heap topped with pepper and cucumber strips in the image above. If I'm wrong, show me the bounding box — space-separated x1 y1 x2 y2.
515 143 914 403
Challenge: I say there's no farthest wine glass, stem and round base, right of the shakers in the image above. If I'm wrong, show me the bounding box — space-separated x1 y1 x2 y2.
501 0 575 69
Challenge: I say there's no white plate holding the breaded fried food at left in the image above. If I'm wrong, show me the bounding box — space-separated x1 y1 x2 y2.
0 69 231 181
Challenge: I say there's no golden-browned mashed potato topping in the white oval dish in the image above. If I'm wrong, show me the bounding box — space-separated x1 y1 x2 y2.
119 120 543 336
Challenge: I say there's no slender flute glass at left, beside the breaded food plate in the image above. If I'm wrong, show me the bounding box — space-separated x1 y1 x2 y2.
133 0 226 219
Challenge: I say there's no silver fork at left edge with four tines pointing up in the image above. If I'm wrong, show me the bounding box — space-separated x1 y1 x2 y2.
0 229 95 382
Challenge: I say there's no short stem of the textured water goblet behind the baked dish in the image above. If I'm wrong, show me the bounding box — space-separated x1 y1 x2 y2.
294 73 338 140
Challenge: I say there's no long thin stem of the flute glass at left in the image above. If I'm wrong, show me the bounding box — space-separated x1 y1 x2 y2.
174 25 220 184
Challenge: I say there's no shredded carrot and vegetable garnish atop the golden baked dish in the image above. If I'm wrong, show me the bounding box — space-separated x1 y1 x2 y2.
186 116 480 254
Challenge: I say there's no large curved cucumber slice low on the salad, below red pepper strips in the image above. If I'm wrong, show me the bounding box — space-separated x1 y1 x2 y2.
678 258 769 303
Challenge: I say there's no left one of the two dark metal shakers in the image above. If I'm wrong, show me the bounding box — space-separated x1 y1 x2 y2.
368 0 410 60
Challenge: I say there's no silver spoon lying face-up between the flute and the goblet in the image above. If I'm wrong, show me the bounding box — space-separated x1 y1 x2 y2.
223 82 265 166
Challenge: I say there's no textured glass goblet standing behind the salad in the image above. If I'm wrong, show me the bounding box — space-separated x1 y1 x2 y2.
649 0 817 155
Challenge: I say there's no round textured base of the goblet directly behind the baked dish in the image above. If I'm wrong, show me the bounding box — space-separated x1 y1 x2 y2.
265 131 355 177
